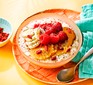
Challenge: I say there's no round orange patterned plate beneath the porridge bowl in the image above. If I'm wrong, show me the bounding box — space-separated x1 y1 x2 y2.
13 9 86 84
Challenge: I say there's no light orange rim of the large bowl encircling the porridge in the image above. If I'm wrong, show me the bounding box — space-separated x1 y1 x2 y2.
16 12 82 68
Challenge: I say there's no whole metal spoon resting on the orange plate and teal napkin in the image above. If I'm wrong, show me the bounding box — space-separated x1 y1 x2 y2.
57 47 93 82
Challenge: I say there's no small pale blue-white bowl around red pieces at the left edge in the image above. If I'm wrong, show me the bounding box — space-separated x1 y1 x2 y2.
0 18 12 47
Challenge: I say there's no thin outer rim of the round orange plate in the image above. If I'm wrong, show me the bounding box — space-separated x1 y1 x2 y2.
12 9 88 85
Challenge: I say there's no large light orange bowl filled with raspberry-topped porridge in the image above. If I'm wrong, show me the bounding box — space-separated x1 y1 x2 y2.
16 12 82 68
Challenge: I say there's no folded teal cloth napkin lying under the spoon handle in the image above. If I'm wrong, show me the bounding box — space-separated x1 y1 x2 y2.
72 4 93 78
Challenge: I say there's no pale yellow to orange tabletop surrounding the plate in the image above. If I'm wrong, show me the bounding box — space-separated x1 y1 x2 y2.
0 0 93 85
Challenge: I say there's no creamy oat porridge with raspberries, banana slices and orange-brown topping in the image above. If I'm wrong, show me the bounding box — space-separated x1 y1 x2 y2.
18 18 79 63
